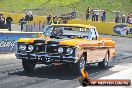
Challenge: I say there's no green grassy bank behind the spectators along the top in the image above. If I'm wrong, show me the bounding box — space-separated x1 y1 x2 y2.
0 0 132 19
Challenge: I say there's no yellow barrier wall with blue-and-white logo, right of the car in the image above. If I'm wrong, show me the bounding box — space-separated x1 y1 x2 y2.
68 19 132 37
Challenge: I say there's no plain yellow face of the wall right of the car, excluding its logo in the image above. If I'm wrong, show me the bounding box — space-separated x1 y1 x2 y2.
68 20 132 35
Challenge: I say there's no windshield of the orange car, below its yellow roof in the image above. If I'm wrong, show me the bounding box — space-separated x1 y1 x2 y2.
44 26 89 37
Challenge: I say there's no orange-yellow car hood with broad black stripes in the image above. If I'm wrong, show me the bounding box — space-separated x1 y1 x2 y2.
18 37 104 46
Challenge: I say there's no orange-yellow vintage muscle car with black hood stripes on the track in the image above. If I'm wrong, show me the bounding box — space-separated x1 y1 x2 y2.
16 24 115 73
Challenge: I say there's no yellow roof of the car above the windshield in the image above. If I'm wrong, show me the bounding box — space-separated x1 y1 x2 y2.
50 24 95 28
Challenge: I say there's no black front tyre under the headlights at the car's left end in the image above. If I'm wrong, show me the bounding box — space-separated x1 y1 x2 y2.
22 60 36 72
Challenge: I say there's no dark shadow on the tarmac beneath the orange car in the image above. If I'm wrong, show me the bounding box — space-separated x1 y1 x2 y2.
8 65 111 80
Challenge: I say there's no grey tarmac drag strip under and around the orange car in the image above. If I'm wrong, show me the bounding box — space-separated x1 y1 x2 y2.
0 35 132 88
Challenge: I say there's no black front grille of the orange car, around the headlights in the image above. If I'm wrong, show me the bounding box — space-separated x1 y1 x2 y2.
17 43 75 55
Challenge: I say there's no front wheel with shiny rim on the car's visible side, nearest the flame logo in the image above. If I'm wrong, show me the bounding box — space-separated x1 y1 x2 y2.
72 55 86 75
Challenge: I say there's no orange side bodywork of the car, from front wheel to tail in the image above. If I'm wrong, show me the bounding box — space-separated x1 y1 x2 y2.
77 38 115 63
